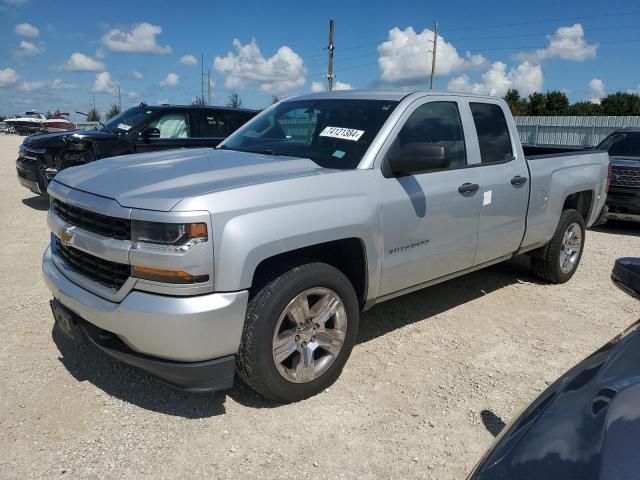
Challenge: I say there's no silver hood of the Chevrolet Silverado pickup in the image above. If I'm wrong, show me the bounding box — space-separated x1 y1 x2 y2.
54 148 336 211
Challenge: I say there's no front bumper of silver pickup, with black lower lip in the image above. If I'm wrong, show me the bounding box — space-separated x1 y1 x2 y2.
42 248 249 391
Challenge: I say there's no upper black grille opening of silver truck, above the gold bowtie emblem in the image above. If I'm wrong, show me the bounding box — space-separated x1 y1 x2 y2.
51 199 131 240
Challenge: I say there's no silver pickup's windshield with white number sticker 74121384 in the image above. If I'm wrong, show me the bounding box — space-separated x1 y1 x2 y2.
220 99 398 169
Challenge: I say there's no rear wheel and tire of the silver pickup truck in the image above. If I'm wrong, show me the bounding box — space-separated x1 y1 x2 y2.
531 209 585 283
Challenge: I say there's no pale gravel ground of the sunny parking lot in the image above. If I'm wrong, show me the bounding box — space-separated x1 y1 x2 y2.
0 132 640 480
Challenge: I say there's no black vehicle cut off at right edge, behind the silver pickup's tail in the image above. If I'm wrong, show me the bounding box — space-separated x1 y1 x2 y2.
596 127 640 222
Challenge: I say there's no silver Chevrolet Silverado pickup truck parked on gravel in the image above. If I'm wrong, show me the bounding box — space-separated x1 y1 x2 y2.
42 91 609 402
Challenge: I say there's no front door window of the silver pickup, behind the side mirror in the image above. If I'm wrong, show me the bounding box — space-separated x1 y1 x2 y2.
398 102 467 169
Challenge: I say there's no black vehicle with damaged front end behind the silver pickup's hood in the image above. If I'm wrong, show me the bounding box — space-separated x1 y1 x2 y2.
16 104 258 195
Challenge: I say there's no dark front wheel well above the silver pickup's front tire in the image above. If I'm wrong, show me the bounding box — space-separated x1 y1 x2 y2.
251 238 367 307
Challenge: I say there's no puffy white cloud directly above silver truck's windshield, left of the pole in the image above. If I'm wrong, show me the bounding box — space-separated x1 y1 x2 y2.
213 38 307 94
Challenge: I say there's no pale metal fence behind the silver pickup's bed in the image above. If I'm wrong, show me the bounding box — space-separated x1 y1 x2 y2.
515 116 640 146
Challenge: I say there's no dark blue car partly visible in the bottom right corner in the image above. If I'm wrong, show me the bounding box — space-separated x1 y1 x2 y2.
469 257 640 480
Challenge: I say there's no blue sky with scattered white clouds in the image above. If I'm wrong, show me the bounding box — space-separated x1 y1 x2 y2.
0 0 640 120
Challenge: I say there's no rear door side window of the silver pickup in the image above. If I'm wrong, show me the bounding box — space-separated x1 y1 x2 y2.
470 103 513 163
